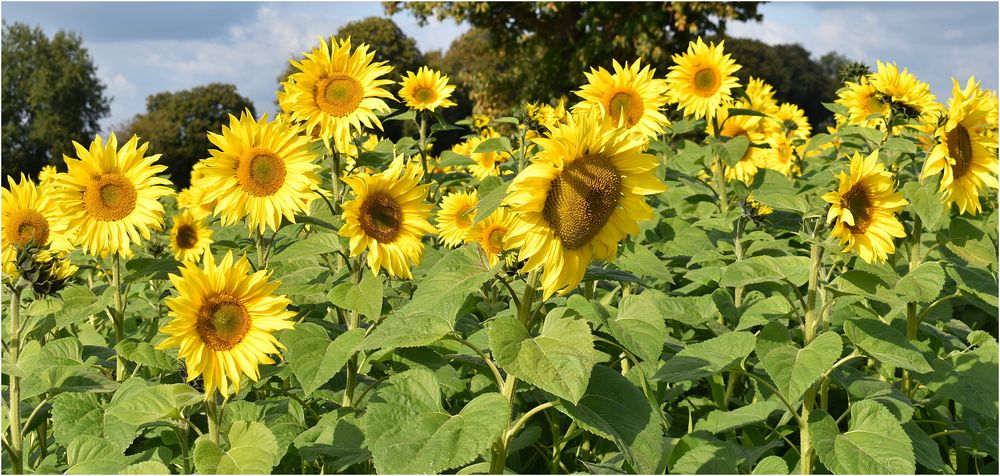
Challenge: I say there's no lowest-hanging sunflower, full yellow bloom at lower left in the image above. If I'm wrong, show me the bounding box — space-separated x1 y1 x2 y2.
156 252 295 400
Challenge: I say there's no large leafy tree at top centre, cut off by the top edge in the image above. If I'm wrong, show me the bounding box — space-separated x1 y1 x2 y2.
383 2 760 109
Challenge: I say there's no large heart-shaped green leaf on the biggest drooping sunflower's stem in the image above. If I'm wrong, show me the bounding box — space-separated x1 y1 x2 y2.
488 312 597 404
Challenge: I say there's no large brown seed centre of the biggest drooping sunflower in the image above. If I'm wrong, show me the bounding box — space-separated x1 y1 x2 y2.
542 154 622 250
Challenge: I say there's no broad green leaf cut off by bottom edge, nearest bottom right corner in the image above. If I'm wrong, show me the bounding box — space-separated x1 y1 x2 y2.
824 400 917 474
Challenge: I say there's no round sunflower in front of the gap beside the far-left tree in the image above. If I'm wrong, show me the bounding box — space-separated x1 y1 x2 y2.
53 133 173 256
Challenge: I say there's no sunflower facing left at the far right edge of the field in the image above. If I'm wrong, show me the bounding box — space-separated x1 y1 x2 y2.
921 77 998 215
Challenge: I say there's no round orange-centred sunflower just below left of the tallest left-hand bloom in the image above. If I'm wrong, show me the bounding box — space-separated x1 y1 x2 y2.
204 111 319 232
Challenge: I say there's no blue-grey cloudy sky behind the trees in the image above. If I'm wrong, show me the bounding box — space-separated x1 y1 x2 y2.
0 1 1000 132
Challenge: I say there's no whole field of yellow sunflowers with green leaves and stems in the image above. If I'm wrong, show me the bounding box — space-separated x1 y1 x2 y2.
2 34 1000 474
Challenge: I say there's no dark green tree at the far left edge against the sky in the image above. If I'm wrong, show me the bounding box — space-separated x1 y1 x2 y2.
2 22 111 177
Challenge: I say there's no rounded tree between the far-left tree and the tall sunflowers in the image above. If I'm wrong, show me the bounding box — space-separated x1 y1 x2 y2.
122 83 254 188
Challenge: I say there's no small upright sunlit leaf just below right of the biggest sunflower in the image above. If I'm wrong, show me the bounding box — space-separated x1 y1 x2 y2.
608 293 667 362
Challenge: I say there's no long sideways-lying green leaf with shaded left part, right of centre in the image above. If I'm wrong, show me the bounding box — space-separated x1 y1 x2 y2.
653 332 756 382
